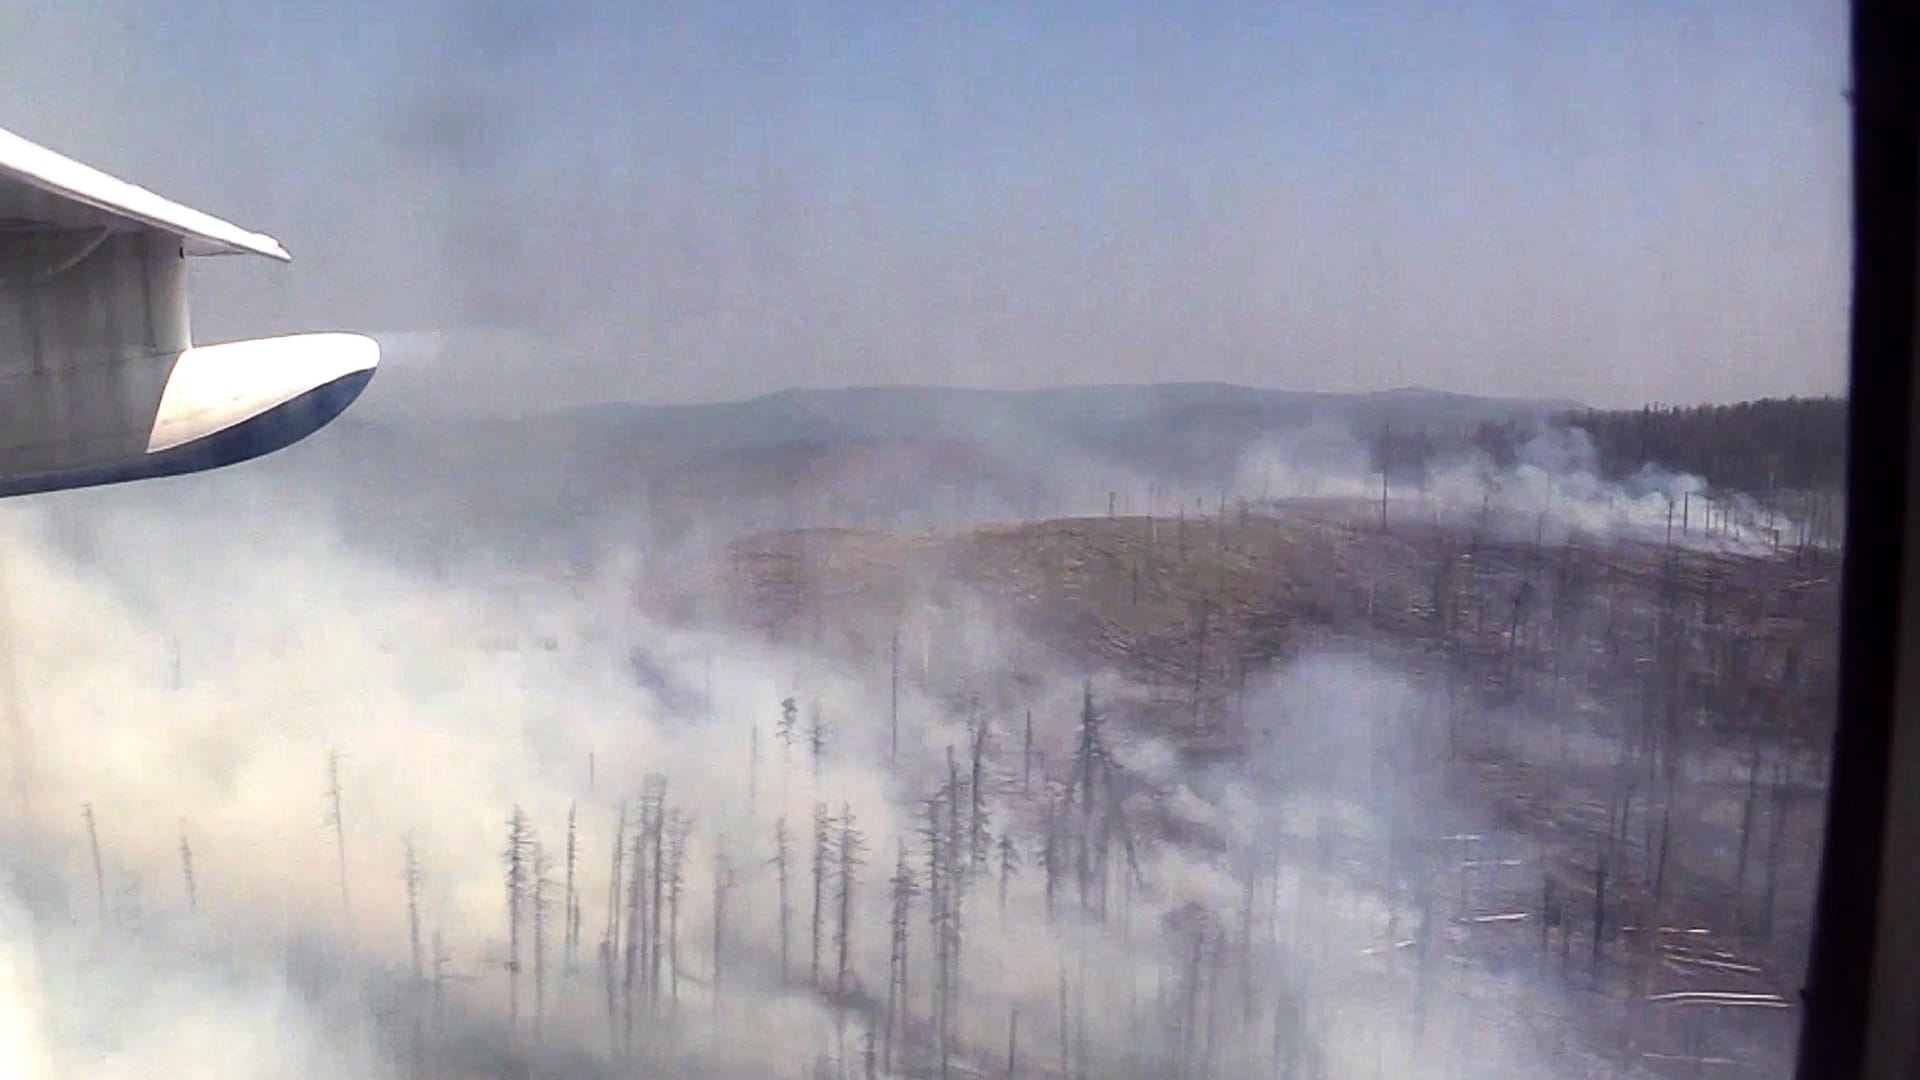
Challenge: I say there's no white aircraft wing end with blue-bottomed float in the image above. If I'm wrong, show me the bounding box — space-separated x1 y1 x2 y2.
0 121 380 496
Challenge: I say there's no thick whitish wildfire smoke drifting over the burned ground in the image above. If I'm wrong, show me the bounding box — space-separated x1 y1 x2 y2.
4 388 1835 1076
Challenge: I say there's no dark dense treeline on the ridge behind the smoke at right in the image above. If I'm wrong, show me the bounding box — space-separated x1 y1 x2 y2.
1371 398 1847 494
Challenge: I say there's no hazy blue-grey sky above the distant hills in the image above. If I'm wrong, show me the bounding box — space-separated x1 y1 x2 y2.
0 0 1849 405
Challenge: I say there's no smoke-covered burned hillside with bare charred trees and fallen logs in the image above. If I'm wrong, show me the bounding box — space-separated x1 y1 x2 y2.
8 386 1839 1080
